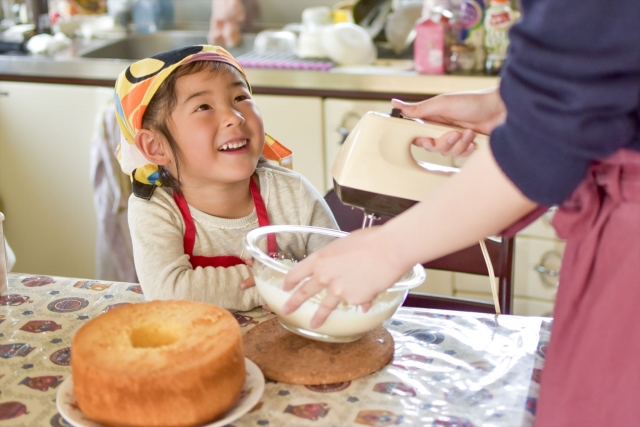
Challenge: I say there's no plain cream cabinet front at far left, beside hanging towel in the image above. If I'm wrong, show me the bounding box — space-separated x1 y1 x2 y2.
0 82 113 278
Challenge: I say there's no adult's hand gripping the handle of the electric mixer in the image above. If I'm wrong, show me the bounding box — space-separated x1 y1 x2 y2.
391 88 507 157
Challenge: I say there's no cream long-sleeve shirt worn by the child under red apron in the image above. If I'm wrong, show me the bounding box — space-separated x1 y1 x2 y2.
129 164 338 310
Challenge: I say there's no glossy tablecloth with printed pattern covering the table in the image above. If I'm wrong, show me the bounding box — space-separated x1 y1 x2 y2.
0 274 551 427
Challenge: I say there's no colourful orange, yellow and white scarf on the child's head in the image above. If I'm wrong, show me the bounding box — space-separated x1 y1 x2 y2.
115 45 292 198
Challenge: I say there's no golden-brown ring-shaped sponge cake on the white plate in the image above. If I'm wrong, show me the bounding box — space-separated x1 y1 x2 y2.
71 301 246 427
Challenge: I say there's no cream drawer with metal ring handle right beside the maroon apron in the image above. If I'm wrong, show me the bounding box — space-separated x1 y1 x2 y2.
514 236 565 301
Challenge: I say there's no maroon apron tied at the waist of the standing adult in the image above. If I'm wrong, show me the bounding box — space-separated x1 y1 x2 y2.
510 150 640 427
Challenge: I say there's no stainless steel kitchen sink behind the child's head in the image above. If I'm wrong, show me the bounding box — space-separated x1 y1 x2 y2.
80 31 255 61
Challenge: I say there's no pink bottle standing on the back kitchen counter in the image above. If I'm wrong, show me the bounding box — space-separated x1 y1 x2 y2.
413 19 445 74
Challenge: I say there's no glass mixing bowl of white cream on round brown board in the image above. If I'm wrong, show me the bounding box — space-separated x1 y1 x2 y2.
244 225 426 343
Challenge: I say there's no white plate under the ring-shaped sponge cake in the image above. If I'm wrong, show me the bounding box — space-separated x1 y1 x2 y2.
56 358 264 427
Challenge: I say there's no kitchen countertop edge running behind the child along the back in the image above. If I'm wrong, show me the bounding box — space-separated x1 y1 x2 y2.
0 32 499 99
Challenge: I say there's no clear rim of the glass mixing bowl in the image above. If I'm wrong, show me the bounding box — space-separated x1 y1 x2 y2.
243 225 426 292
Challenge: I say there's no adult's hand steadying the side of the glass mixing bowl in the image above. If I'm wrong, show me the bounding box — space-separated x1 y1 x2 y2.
282 227 408 328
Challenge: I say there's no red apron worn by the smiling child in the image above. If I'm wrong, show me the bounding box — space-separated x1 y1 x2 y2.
173 178 278 269
